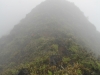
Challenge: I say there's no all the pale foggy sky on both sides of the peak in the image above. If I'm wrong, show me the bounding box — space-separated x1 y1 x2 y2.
0 0 100 37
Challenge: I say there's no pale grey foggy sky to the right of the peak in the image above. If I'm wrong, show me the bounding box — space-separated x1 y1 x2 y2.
68 0 100 31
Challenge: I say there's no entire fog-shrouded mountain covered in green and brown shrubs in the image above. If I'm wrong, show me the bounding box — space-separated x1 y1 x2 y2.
0 0 100 75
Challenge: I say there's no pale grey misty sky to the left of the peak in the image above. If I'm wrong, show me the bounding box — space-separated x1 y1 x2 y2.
0 0 44 37
